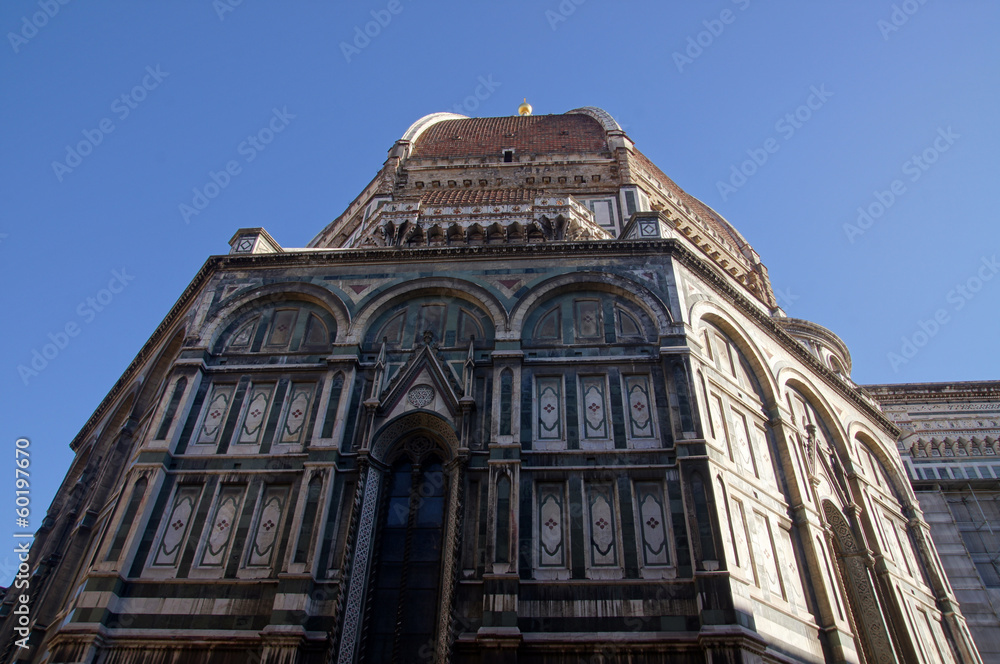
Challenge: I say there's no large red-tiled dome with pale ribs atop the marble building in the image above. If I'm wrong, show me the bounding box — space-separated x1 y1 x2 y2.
309 106 778 312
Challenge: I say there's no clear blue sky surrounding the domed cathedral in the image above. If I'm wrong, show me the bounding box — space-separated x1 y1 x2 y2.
0 0 1000 552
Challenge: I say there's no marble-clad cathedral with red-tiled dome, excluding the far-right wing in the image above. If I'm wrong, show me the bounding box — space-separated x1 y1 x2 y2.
0 103 993 664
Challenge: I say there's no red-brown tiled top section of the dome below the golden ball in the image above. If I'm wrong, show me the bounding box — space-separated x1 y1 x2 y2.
411 113 608 158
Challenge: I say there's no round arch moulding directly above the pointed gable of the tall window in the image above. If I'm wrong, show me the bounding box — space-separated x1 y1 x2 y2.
344 277 508 343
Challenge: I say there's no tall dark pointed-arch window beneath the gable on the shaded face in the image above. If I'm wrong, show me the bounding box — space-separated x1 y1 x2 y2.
337 411 463 664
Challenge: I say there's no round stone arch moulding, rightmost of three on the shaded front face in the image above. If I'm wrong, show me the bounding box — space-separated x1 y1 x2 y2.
508 272 673 339
